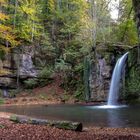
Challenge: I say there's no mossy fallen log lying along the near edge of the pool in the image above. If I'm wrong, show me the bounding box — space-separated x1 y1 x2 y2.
10 115 83 131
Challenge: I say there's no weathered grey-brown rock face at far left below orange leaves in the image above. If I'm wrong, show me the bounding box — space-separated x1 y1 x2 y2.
0 46 37 89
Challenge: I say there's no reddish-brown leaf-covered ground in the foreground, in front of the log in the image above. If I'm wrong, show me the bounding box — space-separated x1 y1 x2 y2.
0 113 140 140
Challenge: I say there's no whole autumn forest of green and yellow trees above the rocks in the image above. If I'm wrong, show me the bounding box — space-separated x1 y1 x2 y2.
0 0 139 101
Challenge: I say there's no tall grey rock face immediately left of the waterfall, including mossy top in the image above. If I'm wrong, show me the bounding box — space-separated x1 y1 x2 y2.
89 45 117 102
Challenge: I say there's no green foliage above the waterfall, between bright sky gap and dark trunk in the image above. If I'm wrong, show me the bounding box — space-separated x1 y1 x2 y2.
111 0 138 45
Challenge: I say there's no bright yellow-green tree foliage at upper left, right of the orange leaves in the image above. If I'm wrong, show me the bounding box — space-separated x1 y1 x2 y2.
8 0 43 44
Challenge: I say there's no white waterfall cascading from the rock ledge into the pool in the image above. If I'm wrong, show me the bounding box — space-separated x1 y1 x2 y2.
107 52 128 105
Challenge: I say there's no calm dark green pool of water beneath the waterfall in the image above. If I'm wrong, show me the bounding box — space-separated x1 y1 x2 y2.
0 104 140 127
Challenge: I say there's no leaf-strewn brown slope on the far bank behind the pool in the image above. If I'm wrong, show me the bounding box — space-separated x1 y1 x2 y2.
4 82 92 105
